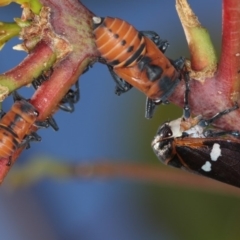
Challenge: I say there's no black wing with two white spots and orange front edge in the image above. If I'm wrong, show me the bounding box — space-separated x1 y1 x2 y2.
172 138 240 187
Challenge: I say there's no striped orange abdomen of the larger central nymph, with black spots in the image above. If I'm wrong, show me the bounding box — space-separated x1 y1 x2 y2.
93 17 146 68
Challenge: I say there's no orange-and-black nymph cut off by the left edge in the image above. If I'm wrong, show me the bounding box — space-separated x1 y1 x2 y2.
0 99 41 166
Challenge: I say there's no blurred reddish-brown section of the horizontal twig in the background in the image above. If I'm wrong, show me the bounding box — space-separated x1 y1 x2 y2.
72 160 240 197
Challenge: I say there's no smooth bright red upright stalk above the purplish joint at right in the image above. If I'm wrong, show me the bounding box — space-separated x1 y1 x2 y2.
217 0 240 100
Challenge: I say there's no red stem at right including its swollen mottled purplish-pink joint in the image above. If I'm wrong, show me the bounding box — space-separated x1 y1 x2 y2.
169 0 240 131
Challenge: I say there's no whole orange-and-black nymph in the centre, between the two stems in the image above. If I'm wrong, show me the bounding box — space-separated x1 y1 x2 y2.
93 16 184 118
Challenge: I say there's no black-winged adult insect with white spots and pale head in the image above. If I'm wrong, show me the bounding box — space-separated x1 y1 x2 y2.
152 78 240 187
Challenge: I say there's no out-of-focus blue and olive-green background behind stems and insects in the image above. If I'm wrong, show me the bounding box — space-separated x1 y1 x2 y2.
0 0 240 240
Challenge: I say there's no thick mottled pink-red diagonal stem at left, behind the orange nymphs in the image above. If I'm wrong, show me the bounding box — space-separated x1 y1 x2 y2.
0 0 98 183
